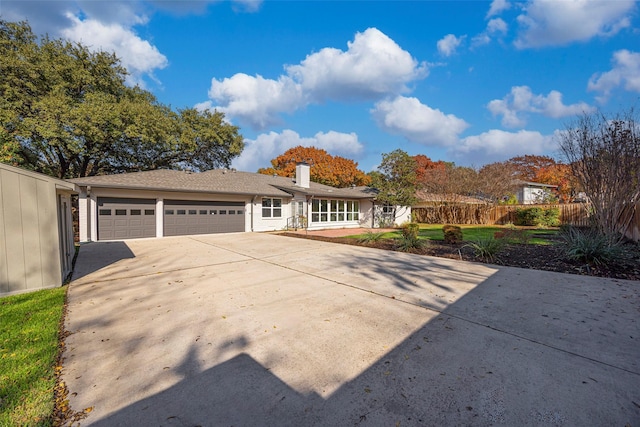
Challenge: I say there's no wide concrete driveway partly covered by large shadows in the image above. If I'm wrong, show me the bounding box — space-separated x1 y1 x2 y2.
63 233 640 427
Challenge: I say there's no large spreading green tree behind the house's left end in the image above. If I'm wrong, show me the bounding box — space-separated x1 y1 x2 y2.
0 20 244 178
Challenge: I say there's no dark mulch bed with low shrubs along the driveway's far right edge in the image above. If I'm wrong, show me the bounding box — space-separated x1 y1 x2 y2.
280 233 640 280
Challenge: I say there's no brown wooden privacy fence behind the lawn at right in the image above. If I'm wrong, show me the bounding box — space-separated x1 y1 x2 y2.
411 202 640 242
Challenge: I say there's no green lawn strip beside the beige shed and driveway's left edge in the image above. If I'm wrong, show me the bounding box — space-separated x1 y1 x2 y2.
0 287 67 426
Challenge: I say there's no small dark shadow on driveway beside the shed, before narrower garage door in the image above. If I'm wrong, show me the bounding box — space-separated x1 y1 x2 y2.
71 242 135 280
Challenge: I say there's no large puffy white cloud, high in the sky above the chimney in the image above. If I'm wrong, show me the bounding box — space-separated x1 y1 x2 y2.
209 28 427 129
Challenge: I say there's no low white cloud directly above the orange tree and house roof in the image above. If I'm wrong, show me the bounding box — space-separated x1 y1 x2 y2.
233 129 363 172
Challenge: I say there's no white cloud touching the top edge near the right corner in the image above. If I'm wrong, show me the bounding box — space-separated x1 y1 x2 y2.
515 0 635 49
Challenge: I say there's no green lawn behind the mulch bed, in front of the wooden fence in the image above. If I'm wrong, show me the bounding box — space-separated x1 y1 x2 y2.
349 224 558 245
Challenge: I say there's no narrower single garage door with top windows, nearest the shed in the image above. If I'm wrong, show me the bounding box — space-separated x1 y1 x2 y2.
98 197 156 240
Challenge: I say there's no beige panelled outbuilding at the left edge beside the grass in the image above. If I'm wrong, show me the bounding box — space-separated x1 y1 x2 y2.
0 164 78 296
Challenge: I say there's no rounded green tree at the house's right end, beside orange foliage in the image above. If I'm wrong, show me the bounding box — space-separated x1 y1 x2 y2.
369 149 418 206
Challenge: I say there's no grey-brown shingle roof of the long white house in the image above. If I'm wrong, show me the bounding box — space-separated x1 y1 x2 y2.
69 169 377 199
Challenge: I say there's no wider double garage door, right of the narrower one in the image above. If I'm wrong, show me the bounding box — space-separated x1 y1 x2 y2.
164 200 245 236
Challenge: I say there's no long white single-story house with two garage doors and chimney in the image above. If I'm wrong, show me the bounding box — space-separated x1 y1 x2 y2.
71 163 411 242
